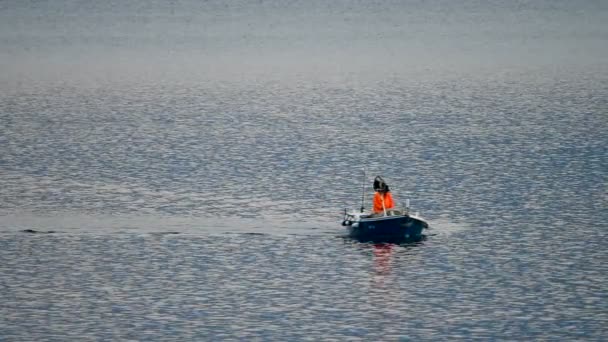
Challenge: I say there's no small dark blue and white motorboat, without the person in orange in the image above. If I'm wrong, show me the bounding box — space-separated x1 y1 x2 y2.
342 207 429 243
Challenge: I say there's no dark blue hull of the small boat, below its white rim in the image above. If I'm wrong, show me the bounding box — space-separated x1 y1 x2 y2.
347 215 428 242
